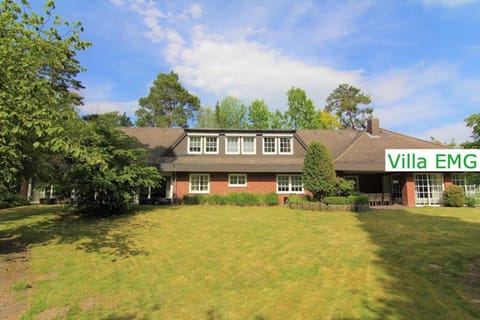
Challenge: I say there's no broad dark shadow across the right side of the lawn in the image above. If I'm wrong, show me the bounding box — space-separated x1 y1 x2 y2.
357 209 480 319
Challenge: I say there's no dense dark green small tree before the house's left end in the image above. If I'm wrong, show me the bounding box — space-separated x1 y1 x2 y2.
59 114 161 216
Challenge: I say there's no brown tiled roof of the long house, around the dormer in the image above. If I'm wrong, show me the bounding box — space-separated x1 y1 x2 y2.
121 128 444 173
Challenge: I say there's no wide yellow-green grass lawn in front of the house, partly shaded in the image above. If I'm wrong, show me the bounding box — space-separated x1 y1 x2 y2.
0 206 480 320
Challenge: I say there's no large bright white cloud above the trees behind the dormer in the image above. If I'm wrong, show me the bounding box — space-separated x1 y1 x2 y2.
174 28 361 109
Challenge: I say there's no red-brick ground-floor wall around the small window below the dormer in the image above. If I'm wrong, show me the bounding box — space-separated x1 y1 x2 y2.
174 173 288 203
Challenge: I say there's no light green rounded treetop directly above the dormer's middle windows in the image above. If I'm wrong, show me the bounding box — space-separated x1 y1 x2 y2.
215 96 248 129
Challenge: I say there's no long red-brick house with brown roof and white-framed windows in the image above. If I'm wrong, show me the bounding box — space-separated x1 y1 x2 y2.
122 119 476 206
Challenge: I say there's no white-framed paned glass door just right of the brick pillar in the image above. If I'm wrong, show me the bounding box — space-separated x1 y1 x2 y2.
414 173 443 206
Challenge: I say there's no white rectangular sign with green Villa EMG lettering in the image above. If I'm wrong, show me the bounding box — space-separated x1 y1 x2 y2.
385 149 480 172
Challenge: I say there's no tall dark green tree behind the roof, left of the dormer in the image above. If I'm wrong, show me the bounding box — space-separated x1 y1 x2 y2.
135 71 200 128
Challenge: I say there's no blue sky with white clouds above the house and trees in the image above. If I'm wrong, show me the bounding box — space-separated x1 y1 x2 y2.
46 0 480 143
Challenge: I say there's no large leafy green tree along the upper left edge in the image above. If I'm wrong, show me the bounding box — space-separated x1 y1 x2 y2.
0 0 90 189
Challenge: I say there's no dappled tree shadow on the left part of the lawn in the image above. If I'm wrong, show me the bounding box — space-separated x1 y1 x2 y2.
0 206 173 258
